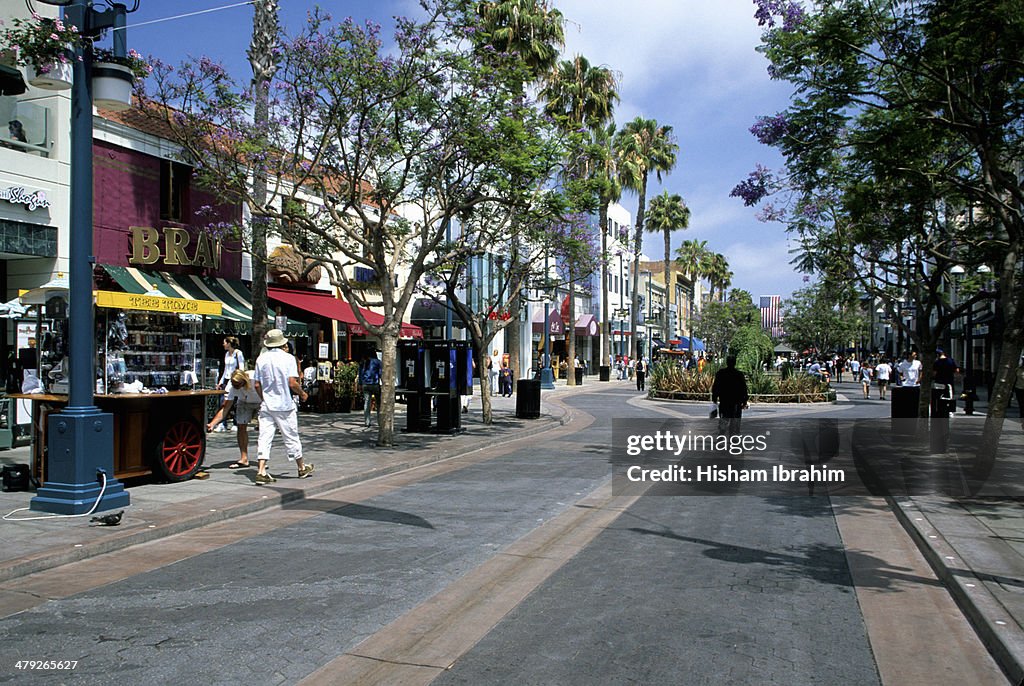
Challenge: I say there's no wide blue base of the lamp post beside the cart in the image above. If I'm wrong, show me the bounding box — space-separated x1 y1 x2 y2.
30 408 131 514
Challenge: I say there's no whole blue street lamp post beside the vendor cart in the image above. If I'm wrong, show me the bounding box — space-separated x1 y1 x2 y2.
30 0 130 514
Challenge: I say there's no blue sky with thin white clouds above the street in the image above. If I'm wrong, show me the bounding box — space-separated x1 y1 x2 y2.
121 0 803 298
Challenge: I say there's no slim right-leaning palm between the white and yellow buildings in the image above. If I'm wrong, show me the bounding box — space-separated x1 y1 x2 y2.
615 117 679 357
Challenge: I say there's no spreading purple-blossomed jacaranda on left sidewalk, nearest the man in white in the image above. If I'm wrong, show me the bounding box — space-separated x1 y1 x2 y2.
146 0 561 446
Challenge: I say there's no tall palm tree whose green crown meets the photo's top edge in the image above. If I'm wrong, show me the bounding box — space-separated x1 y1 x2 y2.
472 0 565 383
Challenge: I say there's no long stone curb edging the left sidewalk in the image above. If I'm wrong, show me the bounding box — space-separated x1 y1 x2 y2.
0 393 573 583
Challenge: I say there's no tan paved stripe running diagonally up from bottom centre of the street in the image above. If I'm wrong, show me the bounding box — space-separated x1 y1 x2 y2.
299 479 639 686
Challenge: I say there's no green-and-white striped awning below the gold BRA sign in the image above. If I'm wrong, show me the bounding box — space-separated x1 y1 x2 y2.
103 265 307 336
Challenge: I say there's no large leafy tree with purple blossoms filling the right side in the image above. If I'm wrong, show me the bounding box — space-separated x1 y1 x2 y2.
734 0 1024 471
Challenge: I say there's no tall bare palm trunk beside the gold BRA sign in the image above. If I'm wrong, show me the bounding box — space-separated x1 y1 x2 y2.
248 0 280 351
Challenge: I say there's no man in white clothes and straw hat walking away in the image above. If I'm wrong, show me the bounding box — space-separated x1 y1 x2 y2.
253 329 313 484
